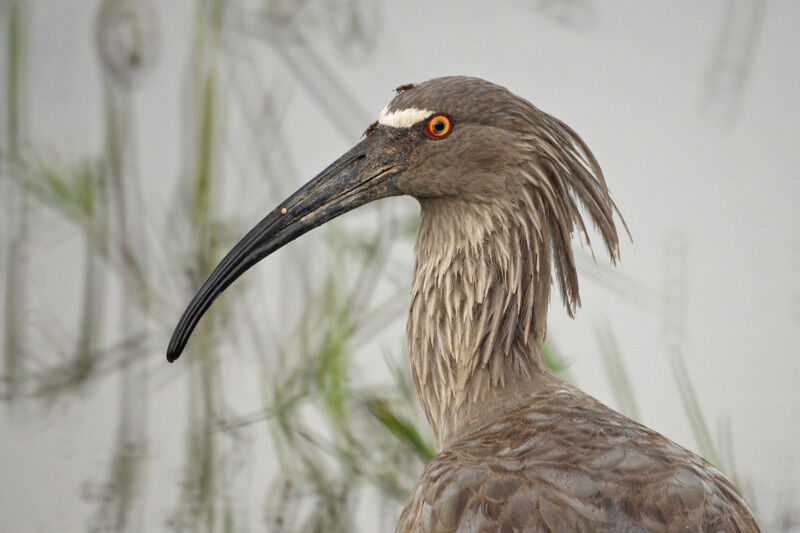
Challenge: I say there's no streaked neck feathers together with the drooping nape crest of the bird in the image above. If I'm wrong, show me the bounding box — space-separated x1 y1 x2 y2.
407 113 627 446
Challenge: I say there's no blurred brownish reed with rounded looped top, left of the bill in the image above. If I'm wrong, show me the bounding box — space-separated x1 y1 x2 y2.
89 0 157 531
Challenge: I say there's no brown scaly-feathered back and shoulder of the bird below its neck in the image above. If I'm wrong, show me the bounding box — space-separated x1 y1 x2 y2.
397 390 758 533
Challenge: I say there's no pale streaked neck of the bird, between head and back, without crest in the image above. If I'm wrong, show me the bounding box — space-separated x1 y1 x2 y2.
407 193 552 447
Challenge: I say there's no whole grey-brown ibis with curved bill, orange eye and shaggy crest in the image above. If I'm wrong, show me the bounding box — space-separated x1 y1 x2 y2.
167 77 758 533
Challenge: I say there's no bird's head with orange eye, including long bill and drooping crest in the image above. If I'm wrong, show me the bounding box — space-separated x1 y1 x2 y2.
167 77 617 362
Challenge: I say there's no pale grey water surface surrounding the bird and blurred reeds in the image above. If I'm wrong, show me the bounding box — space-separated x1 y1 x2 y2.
0 0 800 532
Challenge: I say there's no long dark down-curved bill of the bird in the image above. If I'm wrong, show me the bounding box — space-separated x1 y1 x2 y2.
167 128 406 363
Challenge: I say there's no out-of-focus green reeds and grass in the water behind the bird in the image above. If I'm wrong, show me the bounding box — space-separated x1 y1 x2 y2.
0 0 793 532
